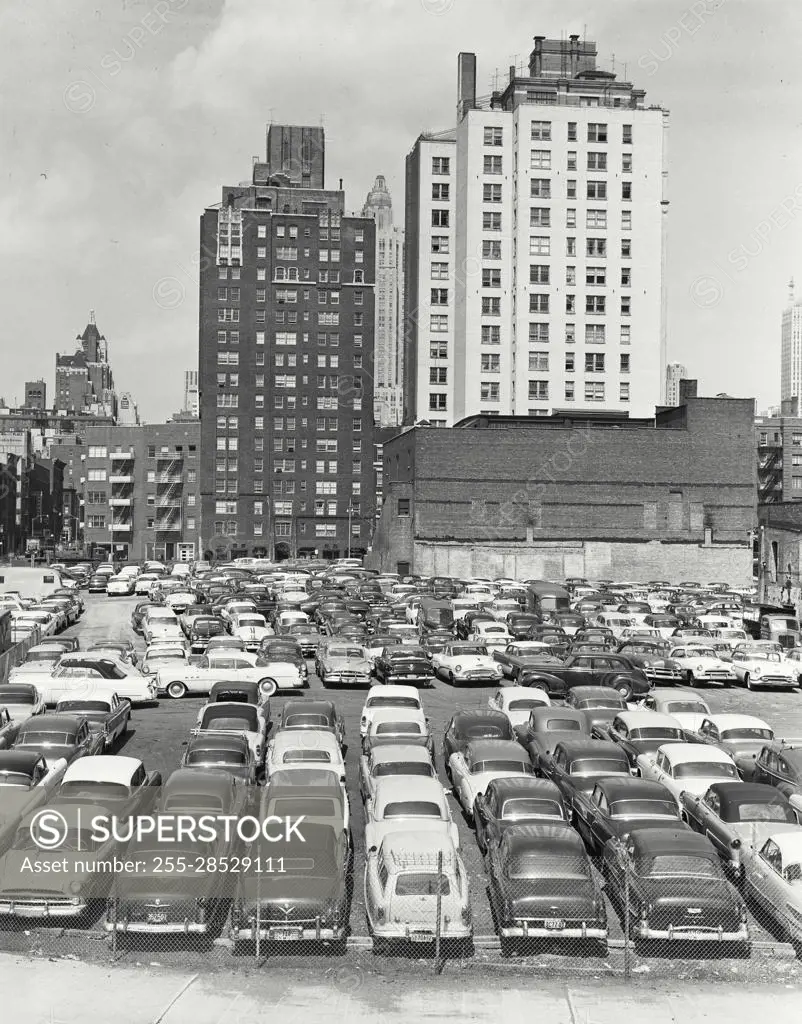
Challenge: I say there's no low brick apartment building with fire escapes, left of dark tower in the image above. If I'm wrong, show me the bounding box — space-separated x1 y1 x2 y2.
51 421 201 561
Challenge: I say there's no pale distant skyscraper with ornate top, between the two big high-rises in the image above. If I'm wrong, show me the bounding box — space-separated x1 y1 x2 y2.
362 174 404 427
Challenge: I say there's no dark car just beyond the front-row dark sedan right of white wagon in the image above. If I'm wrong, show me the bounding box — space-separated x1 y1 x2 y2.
473 775 567 854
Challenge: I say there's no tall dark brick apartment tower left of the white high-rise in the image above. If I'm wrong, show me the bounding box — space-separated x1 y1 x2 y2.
199 125 375 558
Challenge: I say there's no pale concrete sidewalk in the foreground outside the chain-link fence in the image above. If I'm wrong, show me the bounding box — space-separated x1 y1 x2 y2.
0 954 802 1024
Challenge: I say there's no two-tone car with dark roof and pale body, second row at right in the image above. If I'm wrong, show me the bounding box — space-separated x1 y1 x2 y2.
680 782 800 878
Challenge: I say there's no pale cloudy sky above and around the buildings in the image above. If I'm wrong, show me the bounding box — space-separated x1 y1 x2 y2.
0 0 802 421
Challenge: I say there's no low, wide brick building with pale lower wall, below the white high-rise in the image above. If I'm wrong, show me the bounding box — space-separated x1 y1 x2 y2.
367 397 757 584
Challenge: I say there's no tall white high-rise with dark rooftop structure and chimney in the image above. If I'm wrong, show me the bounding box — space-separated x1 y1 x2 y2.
405 36 668 426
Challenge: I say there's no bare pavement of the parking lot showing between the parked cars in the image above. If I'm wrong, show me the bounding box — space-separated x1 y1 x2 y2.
0 596 802 968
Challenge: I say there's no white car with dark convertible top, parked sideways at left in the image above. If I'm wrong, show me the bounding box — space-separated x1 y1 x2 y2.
9 651 156 706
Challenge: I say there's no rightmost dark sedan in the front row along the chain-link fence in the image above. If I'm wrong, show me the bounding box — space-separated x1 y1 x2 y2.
601 826 749 945
